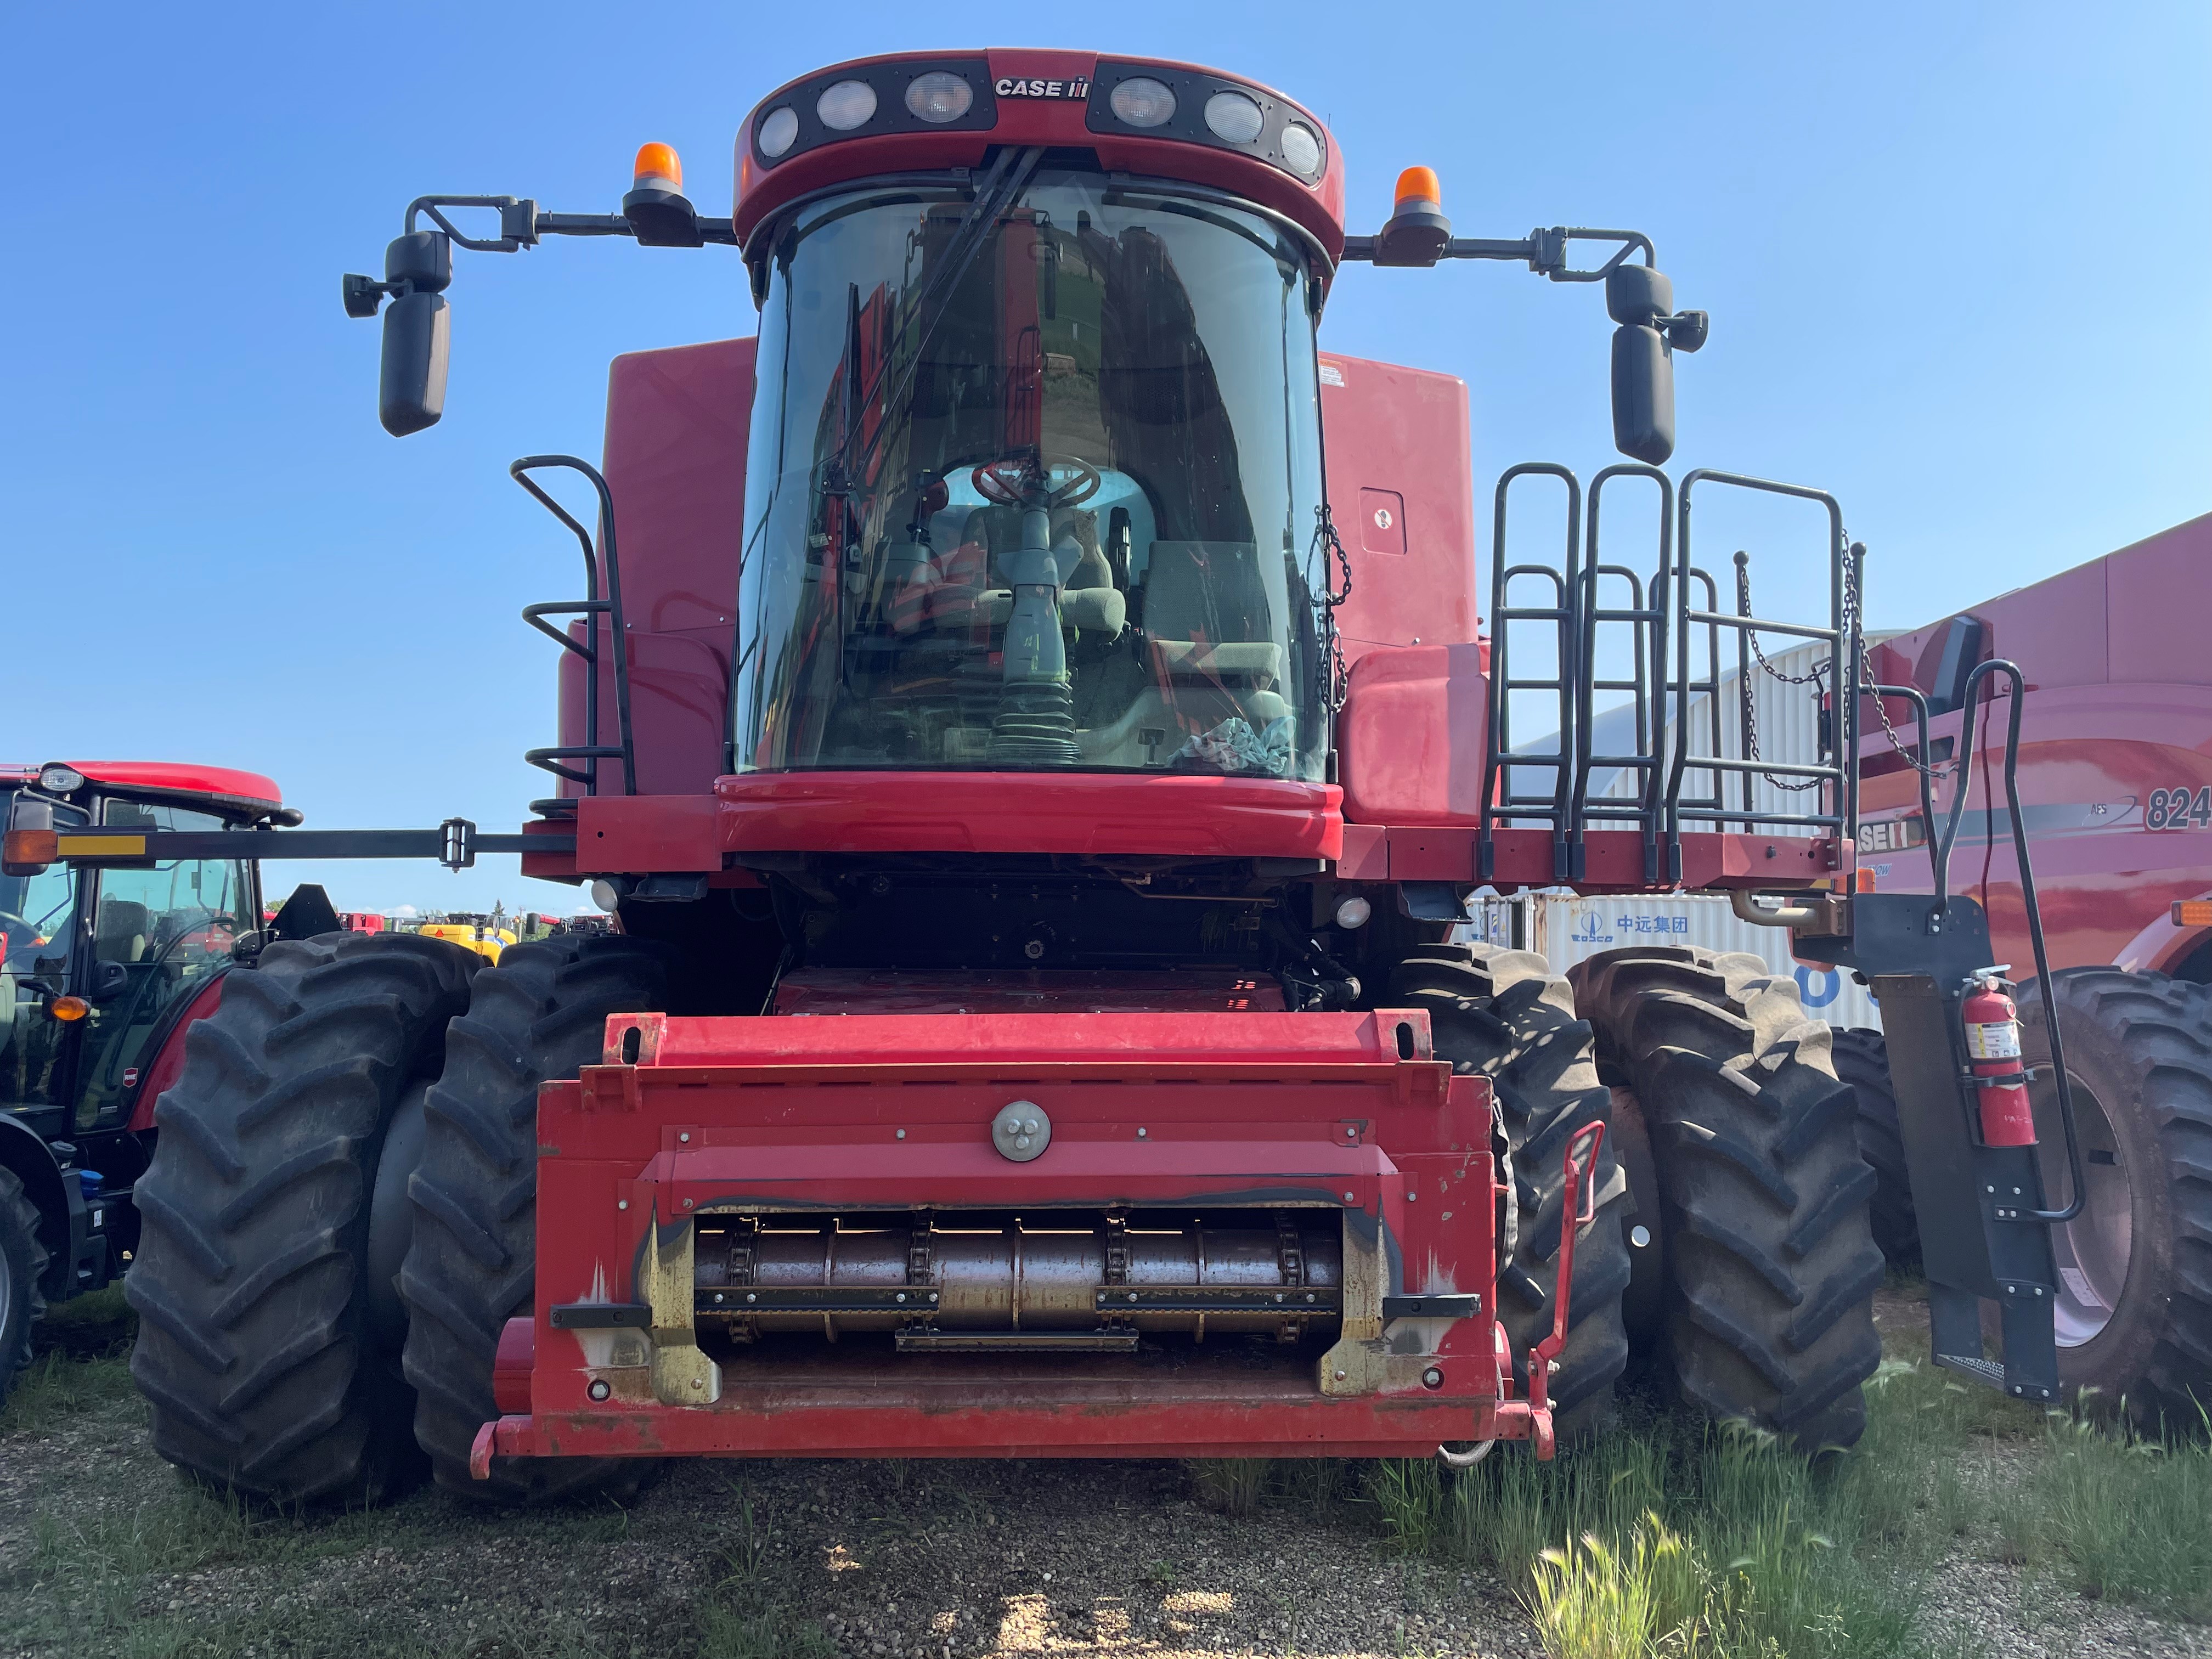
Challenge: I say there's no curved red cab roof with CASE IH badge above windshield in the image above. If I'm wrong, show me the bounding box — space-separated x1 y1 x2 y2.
732 47 1345 263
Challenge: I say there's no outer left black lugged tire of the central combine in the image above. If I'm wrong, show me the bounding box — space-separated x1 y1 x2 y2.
124 934 478 1504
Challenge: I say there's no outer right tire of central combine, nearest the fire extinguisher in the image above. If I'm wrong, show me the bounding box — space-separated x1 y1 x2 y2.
1571 949 1882 1453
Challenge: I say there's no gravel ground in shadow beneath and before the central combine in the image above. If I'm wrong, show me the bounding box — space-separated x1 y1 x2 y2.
0 1303 2212 1659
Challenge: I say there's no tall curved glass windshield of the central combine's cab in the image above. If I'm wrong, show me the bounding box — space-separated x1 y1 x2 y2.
735 170 1327 778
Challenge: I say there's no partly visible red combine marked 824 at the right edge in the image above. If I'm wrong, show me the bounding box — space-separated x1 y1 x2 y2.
1836 515 2212 1425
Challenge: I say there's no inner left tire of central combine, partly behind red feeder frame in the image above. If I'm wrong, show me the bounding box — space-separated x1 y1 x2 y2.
400 934 668 1504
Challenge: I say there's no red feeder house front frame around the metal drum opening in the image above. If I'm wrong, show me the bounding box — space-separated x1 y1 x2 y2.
480 1011 1522 1455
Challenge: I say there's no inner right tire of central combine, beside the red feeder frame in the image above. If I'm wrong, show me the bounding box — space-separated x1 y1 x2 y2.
1387 945 1628 1440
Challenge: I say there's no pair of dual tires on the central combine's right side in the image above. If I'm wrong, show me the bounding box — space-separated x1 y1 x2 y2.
1387 945 1882 1453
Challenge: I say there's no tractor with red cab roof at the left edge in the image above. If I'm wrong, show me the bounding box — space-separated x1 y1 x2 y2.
0 761 330 1396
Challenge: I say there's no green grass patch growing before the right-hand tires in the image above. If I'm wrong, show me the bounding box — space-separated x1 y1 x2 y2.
1369 1358 2212 1659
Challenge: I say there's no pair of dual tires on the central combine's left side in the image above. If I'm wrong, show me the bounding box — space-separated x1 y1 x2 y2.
126 934 666 1504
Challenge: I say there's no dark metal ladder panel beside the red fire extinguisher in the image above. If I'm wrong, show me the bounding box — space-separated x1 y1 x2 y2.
1794 894 2059 1400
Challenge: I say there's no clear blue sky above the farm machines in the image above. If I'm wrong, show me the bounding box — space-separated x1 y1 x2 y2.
0 0 2212 909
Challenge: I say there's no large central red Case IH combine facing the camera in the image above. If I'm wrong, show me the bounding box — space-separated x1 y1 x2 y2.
4 51 2088 1500
